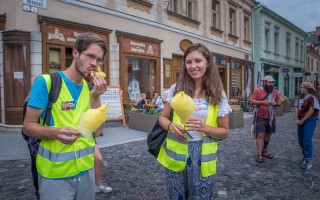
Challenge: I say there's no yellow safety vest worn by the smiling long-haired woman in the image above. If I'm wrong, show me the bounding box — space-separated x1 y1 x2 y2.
157 104 219 177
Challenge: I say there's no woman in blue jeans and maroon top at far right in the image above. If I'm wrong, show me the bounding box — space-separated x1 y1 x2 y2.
296 82 320 169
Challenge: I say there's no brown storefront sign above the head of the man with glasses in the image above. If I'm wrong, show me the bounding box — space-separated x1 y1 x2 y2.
47 25 106 45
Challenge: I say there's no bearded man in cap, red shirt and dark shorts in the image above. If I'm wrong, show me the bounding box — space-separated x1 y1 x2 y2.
250 76 281 163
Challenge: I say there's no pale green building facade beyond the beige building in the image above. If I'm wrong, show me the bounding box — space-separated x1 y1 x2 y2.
253 4 307 99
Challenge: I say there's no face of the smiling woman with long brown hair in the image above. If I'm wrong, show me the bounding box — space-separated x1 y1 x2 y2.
185 50 208 80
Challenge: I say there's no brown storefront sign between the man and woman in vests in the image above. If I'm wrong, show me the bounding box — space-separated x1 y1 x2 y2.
123 38 159 57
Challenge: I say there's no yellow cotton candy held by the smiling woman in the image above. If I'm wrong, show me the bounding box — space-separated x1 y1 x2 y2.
171 91 194 124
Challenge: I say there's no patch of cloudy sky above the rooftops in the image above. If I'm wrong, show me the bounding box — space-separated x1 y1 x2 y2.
256 0 320 32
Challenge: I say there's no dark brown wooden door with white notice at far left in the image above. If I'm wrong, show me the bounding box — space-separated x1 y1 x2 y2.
3 31 31 125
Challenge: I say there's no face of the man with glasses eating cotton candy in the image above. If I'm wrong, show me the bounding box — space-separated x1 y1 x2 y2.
74 44 103 80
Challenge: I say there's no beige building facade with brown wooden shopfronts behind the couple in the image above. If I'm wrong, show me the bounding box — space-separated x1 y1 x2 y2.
0 0 255 125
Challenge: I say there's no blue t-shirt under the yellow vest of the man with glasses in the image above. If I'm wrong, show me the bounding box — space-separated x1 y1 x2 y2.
28 71 82 126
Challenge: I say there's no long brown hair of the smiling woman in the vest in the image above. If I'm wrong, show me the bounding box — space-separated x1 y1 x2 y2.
174 43 223 105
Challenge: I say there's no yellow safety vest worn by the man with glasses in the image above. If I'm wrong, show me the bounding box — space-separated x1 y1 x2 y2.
36 75 95 178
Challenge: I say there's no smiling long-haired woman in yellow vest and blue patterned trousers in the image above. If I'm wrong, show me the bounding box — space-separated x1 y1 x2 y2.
157 43 231 199
